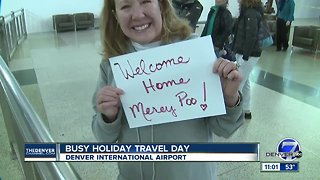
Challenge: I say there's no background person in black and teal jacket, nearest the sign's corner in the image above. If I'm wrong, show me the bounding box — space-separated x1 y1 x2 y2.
201 0 235 60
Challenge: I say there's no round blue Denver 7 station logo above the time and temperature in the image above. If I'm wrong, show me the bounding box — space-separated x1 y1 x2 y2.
266 138 302 161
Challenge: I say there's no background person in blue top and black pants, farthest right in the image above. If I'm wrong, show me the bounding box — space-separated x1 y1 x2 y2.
276 0 295 51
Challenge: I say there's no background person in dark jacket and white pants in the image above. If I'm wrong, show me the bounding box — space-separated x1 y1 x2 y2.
233 0 263 119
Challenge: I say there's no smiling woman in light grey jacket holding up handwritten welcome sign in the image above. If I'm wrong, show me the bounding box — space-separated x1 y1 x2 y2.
92 0 243 180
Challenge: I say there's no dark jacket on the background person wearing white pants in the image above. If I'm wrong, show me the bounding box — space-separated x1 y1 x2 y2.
233 7 263 60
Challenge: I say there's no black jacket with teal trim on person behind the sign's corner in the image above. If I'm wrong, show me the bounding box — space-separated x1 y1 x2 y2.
201 7 233 49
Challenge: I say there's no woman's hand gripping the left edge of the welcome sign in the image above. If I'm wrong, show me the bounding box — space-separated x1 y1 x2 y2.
96 86 123 123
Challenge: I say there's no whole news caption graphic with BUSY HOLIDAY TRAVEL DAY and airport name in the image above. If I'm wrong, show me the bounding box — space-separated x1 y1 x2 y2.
25 143 260 162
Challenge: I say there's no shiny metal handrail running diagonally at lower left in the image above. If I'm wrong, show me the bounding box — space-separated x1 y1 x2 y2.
0 56 80 180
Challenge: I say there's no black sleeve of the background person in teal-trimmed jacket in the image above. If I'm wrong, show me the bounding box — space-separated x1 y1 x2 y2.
215 9 233 49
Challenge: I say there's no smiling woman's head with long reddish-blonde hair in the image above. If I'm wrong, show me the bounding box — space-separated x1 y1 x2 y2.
101 0 192 59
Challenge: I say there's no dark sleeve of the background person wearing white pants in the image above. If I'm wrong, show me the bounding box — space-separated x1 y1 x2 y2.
243 11 259 60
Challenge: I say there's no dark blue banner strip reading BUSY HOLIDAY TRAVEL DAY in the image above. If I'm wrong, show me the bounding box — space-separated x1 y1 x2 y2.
60 143 259 154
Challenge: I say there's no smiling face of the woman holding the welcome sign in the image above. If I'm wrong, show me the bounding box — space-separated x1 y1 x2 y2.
114 0 162 44
